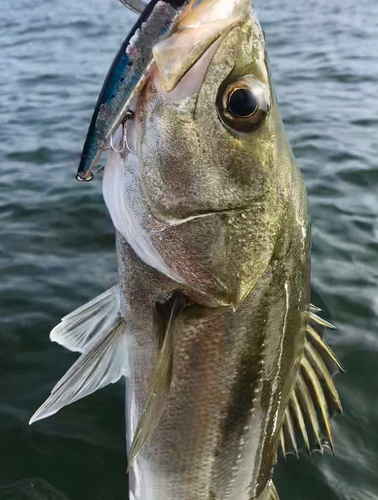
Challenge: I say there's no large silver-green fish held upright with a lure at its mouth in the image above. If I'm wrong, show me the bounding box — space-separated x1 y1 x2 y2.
31 0 344 500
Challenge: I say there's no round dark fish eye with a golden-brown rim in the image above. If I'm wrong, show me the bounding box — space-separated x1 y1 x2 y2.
217 75 270 134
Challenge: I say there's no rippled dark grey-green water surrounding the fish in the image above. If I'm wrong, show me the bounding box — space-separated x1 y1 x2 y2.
0 0 378 500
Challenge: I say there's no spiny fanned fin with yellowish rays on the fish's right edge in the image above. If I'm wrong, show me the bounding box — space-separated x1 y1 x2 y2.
279 305 344 456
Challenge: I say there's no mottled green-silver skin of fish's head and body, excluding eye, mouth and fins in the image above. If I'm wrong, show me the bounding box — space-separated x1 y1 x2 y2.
117 0 310 500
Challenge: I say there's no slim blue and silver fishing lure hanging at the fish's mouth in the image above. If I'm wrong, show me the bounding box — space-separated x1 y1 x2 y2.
76 0 194 182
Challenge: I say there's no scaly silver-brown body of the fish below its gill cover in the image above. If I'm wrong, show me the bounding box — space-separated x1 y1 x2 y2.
118 236 306 500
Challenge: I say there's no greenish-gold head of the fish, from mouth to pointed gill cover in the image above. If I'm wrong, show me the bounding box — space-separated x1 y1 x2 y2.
110 0 303 307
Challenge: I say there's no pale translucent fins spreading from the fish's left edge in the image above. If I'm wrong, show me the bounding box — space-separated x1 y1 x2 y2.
30 287 129 424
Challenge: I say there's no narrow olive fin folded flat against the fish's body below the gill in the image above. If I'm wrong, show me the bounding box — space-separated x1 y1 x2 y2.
128 293 186 468
